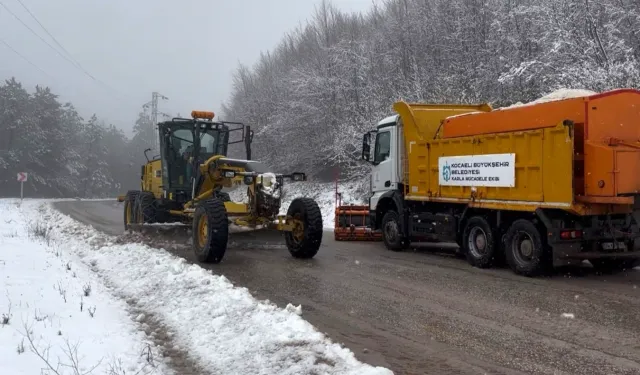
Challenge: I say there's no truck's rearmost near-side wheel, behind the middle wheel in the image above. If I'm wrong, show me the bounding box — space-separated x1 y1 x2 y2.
505 219 551 277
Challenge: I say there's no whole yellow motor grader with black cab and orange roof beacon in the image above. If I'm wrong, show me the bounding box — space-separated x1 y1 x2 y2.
118 111 323 263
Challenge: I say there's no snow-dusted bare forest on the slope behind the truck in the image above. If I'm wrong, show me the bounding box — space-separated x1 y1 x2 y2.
225 0 640 179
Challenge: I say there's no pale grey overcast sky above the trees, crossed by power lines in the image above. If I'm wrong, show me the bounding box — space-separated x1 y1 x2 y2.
0 0 379 135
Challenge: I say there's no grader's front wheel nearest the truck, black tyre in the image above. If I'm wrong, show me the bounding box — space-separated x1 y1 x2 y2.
284 198 323 259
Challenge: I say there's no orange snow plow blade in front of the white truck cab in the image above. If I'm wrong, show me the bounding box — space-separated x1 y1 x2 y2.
333 206 382 241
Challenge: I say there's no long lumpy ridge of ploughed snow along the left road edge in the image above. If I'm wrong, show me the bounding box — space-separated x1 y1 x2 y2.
2 201 392 374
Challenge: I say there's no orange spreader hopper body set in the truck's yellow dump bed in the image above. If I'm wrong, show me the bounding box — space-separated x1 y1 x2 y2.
442 89 640 204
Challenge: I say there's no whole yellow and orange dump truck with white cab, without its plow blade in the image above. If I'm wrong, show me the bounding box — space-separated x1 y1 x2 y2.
362 90 640 276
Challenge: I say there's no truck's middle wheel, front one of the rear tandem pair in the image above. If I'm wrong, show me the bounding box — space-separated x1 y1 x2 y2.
462 216 498 268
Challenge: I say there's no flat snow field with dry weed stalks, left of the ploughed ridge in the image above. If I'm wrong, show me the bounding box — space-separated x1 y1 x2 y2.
0 200 170 375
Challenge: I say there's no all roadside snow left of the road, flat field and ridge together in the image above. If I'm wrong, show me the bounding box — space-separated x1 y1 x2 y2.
0 200 392 375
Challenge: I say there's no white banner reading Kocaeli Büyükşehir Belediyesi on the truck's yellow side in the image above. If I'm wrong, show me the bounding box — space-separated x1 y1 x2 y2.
438 154 516 187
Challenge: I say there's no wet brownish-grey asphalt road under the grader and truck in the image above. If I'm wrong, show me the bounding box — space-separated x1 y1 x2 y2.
57 201 640 375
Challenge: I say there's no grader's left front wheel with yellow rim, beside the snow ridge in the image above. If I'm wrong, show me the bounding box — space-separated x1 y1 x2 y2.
191 198 229 263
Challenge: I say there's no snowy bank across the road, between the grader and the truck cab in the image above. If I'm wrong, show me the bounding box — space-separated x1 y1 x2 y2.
229 181 368 229
